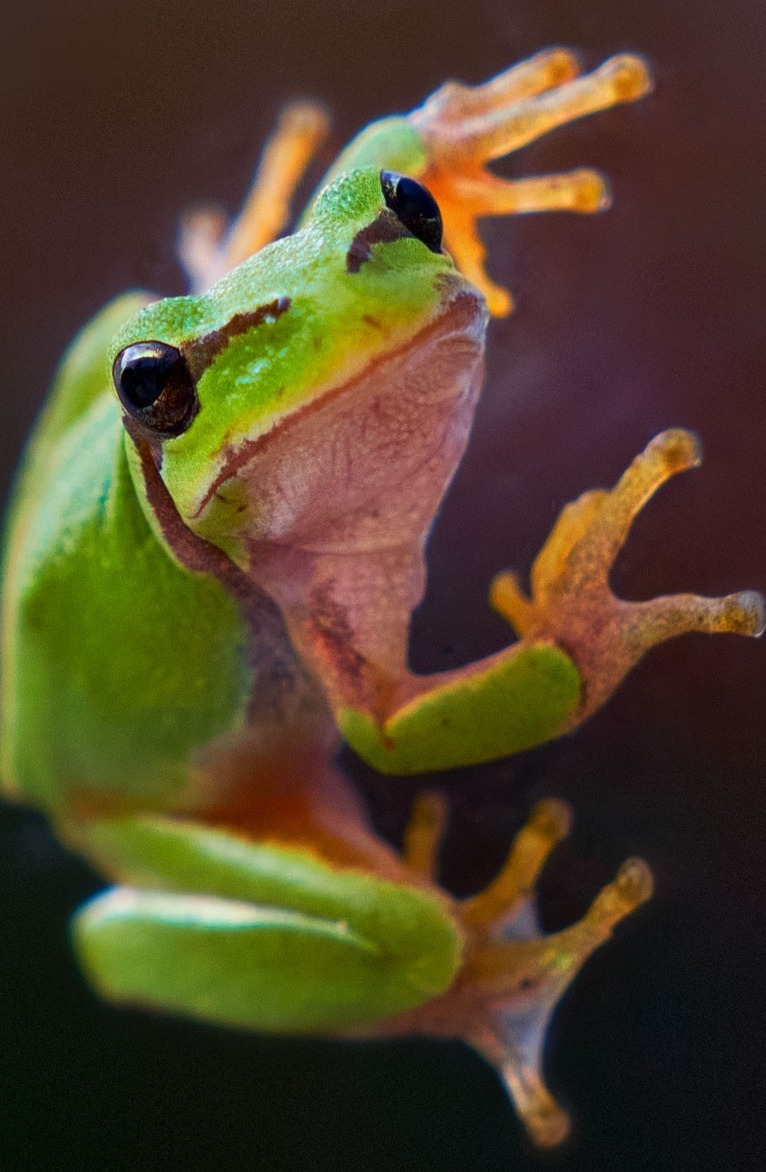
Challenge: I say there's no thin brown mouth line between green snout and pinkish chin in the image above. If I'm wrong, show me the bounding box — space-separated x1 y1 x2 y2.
190 273 487 522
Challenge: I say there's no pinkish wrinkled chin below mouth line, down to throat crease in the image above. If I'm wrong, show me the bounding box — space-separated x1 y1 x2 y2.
190 284 486 565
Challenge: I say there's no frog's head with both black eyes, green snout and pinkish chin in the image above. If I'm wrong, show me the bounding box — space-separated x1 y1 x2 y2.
110 170 486 564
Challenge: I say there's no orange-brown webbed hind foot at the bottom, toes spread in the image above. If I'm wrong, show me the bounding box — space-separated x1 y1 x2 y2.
387 796 652 1147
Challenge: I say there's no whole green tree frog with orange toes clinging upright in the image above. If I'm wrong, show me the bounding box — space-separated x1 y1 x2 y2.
1 49 764 1145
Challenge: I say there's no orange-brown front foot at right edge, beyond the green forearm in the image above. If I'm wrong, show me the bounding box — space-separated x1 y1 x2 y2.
491 429 766 725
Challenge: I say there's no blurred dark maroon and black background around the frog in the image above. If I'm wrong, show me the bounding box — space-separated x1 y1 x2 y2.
0 0 766 1172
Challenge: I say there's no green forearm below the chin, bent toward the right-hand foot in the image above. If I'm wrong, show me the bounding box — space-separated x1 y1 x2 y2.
336 642 581 774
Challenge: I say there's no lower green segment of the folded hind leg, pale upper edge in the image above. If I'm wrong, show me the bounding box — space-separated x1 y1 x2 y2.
75 887 426 1031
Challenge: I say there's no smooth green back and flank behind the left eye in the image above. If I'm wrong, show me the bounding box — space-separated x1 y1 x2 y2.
0 295 251 809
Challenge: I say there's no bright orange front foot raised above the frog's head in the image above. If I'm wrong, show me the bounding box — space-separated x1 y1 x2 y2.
409 49 651 315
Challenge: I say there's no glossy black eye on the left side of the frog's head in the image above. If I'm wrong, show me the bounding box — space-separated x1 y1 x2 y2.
111 342 199 436
